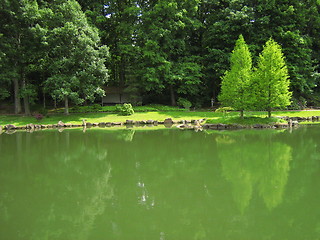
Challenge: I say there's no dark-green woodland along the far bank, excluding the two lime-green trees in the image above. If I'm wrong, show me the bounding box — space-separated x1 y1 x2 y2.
0 0 320 114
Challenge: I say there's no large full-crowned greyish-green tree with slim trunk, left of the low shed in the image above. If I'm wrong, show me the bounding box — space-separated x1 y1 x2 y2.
45 0 108 114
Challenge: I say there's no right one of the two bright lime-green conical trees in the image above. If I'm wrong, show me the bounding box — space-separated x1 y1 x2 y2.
253 38 292 117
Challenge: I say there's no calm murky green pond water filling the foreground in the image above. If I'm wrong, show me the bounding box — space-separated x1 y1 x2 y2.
0 126 320 240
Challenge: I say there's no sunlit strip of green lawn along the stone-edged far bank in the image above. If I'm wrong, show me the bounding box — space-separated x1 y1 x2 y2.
0 111 320 126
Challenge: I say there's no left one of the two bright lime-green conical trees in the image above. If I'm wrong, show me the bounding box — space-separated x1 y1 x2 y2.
219 35 252 118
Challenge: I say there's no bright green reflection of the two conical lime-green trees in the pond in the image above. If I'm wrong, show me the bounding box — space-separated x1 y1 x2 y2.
216 131 292 213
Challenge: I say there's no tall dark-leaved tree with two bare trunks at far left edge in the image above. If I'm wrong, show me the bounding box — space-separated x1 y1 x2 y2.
0 0 41 115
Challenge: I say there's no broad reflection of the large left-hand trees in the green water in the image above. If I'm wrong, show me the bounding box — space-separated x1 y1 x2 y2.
0 131 113 239
